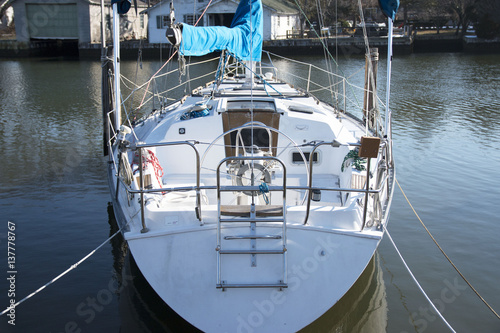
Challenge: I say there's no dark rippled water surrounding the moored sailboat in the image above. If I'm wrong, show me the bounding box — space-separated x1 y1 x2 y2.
0 54 500 332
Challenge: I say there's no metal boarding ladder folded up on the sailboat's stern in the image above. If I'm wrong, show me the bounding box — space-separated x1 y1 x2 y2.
216 156 287 291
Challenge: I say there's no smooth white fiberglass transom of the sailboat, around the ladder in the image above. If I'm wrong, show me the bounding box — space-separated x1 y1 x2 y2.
125 225 380 332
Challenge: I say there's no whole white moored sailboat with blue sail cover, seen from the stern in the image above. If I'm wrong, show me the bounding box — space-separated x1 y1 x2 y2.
103 0 395 332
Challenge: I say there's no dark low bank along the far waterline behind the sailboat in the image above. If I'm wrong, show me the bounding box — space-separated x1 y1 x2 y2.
0 33 500 59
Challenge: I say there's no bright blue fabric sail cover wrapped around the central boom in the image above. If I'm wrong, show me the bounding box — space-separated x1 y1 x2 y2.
179 0 263 61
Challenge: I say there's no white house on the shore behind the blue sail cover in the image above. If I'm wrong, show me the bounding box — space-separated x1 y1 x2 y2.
148 0 300 43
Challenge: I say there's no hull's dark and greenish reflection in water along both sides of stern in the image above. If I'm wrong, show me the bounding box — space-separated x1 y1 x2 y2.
108 204 387 333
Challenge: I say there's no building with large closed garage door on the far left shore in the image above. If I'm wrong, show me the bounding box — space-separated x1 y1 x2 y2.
10 0 147 45
